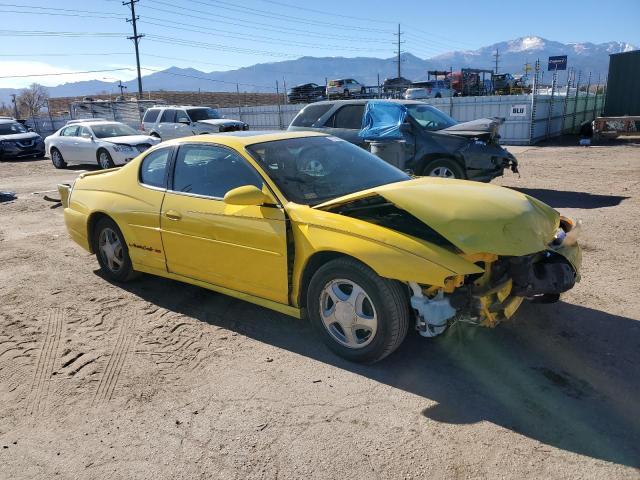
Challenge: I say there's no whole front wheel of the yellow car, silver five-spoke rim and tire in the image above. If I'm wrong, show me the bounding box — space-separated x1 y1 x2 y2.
307 258 410 363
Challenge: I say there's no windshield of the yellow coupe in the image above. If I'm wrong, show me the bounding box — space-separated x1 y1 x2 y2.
247 137 409 205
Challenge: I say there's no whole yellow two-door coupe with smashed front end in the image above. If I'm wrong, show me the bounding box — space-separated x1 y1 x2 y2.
59 132 581 362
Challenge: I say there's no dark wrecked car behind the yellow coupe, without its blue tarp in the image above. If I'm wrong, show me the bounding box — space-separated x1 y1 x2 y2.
289 100 518 182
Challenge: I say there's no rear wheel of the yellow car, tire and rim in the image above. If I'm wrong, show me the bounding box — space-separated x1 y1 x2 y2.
93 217 137 282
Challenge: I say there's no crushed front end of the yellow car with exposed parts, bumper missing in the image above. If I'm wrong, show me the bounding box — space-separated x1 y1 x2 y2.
409 217 582 337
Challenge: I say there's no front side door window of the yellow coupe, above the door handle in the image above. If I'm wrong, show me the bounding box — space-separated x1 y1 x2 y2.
173 145 263 199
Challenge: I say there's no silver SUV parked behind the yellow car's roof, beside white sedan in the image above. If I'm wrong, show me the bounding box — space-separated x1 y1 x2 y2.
142 105 249 140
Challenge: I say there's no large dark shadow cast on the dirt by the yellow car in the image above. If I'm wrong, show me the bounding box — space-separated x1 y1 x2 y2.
102 271 640 467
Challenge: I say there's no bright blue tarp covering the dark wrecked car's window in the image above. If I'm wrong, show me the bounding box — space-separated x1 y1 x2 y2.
358 100 407 140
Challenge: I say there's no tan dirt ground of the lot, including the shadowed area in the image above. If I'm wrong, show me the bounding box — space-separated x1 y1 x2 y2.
0 137 640 480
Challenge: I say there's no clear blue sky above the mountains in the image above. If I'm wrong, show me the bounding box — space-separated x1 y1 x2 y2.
0 0 640 88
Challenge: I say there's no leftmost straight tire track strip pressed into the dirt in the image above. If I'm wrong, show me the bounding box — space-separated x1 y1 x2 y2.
27 308 65 415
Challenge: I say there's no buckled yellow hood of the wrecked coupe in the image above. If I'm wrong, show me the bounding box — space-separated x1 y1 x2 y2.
315 177 560 256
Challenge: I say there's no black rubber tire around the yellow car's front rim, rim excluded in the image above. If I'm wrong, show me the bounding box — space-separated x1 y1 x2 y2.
307 258 410 363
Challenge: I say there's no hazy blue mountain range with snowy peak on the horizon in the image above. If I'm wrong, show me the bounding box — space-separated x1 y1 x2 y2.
0 36 638 103
